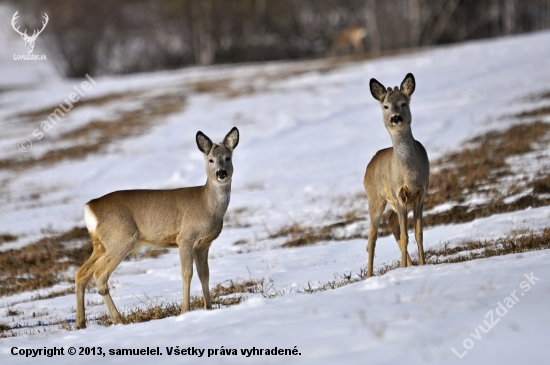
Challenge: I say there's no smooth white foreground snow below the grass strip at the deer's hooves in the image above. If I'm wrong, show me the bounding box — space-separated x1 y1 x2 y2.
0 245 550 364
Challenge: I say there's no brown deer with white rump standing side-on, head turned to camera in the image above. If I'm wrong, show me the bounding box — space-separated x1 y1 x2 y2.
75 127 239 329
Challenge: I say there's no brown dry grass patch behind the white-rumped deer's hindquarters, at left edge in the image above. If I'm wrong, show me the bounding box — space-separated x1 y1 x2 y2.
0 228 92 296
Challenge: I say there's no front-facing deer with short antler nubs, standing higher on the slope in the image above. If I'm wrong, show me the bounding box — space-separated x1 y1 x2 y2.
363 73 430 277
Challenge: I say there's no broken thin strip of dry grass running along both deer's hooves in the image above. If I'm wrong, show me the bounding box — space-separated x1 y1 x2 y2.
0 228 550 338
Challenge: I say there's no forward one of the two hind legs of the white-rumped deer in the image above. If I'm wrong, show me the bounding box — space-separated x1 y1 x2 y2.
93 229 139 324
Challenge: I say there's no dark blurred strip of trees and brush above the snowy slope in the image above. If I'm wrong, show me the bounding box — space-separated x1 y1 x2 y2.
4 0 550 77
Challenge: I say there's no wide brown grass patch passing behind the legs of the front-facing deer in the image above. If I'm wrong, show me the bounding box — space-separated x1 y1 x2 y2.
276 121 550 247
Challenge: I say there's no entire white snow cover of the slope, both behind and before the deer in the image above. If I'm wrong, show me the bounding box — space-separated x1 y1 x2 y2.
0 19 550 364
